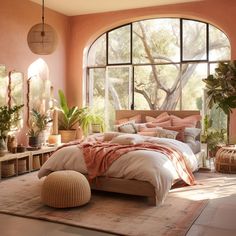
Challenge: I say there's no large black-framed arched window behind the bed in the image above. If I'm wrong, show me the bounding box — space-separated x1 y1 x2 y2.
86 18 231 129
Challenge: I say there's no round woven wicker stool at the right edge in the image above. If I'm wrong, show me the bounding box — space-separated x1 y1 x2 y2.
215 146 236 174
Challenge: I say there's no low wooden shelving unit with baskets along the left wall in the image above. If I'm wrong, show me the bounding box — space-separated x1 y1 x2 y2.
0 147 57 180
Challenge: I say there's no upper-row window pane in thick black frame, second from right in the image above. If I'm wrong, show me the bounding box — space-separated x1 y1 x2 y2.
183 20 207 61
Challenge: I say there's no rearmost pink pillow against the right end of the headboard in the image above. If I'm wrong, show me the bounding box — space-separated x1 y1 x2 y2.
171 115 202 128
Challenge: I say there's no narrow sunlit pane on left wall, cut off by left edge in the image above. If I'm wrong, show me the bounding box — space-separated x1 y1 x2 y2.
0 65 8 106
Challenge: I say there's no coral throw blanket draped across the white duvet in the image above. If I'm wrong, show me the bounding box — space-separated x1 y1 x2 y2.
78 142 195 185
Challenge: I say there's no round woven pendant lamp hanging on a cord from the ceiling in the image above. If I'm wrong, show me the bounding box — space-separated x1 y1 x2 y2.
27 0 57 55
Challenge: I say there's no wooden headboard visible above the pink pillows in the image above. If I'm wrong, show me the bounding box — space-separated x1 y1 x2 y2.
116 110 201 128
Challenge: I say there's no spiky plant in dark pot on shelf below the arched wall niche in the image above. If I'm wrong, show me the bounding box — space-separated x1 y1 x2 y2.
28 109 52 148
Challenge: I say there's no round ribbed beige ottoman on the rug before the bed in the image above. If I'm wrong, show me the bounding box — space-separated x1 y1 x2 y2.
41 170 91 208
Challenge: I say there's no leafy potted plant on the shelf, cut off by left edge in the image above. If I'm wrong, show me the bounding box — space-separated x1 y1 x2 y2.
0 105 24 155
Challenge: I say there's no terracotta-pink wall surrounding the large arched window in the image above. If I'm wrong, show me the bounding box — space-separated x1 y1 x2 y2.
67 0 236 140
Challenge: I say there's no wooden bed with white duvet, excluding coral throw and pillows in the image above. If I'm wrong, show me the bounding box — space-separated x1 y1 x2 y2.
38 110 204 206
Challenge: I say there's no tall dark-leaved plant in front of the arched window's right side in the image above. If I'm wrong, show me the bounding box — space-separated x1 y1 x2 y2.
203 61 236 143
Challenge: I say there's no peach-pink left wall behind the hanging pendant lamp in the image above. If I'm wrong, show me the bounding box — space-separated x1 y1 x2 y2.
0 0 69 143
